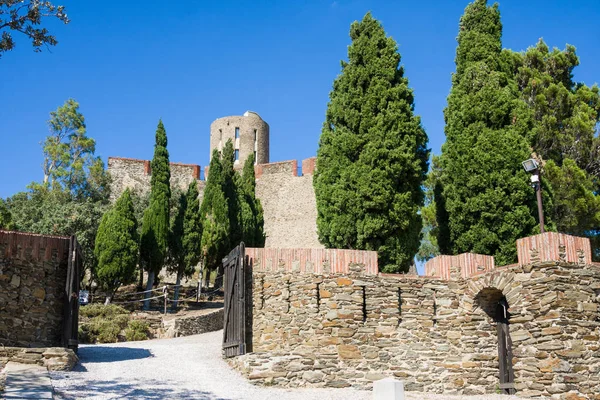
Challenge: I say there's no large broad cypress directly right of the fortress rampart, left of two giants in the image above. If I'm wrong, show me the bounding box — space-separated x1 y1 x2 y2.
314 13 429 272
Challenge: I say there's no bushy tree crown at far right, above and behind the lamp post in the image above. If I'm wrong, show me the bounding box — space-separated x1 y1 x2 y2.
510 39 600 173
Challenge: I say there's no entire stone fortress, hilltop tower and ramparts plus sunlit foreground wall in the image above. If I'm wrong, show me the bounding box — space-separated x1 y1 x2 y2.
108 112 600 400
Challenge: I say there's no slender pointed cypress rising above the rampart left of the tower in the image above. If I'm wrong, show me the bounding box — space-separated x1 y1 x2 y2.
140 120 171 309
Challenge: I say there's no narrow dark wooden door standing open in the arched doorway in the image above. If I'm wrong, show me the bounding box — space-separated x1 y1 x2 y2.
496 298 515 394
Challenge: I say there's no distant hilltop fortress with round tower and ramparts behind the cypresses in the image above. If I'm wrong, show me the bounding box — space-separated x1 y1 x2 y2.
108 111 323 248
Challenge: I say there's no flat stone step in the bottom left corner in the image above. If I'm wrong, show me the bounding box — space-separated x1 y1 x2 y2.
2 361 54 400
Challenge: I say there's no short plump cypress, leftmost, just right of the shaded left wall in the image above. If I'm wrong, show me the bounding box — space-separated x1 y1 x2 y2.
94 189 139 304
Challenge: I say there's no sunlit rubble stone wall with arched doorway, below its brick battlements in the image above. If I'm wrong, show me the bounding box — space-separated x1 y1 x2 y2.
231 236 600 399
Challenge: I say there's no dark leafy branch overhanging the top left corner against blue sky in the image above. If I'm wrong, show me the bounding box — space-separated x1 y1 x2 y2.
0 0 70 57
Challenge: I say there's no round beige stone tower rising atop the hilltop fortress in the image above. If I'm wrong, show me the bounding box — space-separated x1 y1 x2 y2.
210 111 269 168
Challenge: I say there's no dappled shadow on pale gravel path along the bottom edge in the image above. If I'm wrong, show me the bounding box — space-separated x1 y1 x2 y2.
54 378 230 400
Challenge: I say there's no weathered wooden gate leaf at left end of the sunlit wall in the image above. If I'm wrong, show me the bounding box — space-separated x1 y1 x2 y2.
223 243 247 357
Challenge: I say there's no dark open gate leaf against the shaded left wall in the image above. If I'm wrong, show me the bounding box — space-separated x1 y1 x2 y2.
62 236 83 352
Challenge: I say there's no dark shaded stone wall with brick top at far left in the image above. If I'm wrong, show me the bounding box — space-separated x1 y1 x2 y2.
0 231 69 347
